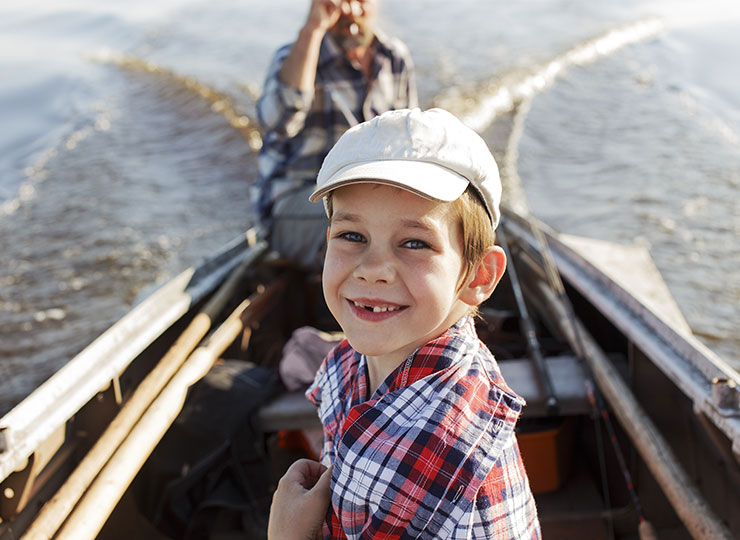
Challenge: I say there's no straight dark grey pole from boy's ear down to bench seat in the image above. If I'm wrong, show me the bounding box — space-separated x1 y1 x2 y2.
496 227 558 415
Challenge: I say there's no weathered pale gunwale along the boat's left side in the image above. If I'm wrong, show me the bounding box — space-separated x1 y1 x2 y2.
0 233 266 482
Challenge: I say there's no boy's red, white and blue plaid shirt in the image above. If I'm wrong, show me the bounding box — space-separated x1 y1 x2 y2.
306 317 540 540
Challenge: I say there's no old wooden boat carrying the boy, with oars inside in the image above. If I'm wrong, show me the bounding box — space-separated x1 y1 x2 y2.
0 212 740 540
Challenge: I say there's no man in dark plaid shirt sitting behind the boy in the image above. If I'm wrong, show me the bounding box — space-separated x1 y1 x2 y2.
253 0 418 268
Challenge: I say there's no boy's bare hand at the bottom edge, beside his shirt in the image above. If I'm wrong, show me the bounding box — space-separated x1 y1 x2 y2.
267 459 331 540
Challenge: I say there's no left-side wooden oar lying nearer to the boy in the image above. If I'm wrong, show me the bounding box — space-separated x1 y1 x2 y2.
56 280 286 540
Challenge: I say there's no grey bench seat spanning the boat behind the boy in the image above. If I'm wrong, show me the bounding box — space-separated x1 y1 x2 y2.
257 356 590 432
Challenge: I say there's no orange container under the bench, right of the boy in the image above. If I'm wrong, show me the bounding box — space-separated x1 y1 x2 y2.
516 417 575 493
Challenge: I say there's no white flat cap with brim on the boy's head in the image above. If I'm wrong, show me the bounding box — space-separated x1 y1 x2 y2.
309 109 501 229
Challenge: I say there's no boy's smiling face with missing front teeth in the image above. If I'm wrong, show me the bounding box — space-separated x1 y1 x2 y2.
323 184 469 370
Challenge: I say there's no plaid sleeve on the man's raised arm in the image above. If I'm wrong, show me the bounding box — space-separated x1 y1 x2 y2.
257 45 314 137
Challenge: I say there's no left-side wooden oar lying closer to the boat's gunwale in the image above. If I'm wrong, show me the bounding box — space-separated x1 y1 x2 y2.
22 242 264 540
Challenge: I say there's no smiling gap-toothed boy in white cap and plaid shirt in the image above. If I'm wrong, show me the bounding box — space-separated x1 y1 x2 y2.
307 109 540 539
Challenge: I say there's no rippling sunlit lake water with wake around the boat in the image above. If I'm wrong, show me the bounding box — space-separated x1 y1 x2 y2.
0 0 740 414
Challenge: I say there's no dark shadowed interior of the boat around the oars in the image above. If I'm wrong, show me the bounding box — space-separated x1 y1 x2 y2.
0 221 740 540
